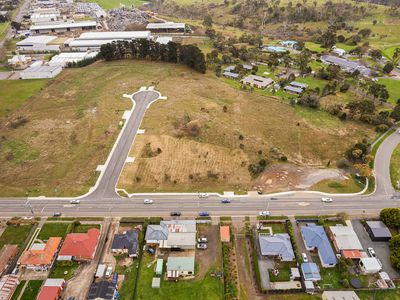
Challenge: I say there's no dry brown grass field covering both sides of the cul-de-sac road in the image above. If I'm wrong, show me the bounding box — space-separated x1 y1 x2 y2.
0 61 372 196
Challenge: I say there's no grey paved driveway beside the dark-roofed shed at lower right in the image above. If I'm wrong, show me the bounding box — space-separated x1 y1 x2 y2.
351 220 400 279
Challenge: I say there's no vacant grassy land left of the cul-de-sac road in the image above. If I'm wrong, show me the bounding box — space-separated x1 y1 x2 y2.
0 64 130 196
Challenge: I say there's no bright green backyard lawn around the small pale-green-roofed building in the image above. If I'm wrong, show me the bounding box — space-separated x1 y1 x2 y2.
136 253 223 300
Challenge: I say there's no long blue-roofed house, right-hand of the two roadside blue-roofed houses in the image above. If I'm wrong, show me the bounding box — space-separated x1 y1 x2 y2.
300 223 337 268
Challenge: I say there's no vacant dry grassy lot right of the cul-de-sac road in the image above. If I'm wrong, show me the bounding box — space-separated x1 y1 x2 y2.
115 62 373 192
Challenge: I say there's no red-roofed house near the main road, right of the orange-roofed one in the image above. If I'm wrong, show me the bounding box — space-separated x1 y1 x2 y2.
58 228 100 261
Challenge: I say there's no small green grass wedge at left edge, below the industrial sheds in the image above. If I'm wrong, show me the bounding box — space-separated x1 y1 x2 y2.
0 79 48 118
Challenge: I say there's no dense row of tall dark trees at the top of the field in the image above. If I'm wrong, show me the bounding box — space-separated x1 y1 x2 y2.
99 39 206 73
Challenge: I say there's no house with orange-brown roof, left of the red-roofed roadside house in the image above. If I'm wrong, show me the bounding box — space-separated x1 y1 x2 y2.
18 237 61 271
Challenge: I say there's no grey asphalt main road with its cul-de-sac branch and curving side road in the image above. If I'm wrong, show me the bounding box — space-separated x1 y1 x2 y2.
0 90 400 217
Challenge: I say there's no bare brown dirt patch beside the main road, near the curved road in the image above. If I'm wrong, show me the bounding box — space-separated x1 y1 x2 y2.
252 164 347 192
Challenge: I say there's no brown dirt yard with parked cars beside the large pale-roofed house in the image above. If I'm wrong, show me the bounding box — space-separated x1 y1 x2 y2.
196 225 221 278
